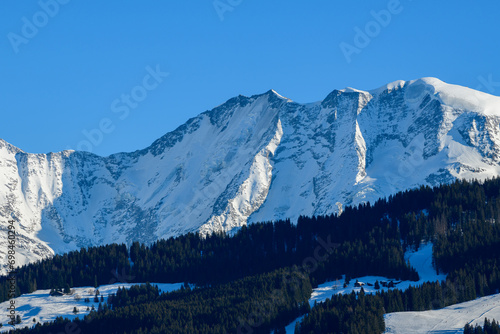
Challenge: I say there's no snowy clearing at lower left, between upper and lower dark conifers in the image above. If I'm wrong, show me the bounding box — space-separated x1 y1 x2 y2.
0 283 183 332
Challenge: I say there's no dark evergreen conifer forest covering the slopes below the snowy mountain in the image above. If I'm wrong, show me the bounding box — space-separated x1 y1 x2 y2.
0 178 500 333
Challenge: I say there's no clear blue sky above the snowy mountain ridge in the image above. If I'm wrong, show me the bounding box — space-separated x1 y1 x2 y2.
0 0 500 155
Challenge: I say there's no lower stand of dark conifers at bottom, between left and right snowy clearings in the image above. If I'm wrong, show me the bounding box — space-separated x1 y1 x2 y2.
4 269 312 334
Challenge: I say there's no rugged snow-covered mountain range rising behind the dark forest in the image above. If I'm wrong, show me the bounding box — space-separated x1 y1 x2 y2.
0 78 500 273
